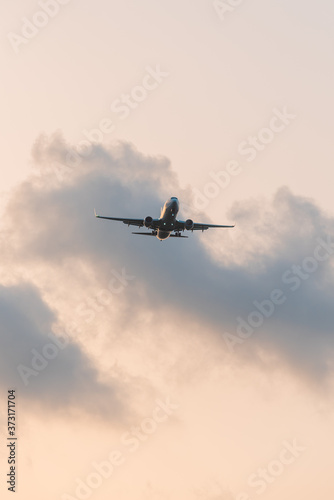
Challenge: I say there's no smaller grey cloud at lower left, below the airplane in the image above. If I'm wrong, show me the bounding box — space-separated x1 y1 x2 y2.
0 283 124 418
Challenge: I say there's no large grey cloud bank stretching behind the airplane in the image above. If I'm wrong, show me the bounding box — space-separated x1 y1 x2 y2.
1 134 334 386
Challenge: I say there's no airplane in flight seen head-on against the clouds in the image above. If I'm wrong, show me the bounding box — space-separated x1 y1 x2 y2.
94 196 234 241
